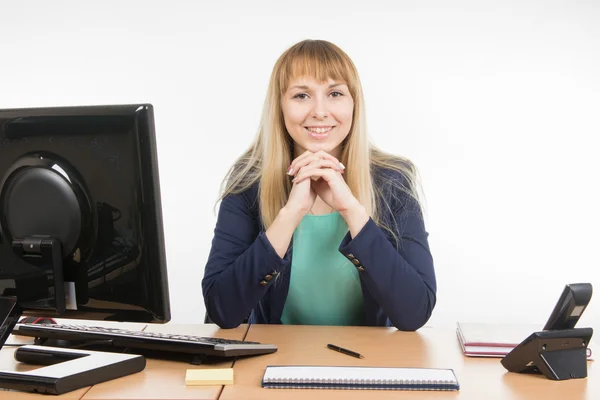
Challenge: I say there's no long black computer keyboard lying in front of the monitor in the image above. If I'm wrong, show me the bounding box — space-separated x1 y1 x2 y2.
13 324 277 357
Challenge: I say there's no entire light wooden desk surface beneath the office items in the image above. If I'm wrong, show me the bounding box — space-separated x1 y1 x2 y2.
0 325 600 400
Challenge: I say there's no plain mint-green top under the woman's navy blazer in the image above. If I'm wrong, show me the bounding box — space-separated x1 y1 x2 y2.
281 212 364 326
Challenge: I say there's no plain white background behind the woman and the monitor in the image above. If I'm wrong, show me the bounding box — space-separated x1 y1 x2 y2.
0 0 600 328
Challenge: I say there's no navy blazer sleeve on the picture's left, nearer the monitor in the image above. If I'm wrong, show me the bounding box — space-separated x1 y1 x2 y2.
202 191 291 328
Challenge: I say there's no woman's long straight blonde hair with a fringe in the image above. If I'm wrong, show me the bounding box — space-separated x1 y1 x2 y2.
219 40 419 242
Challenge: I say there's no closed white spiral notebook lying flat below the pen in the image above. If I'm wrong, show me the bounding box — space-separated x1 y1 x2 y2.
262 365 459 390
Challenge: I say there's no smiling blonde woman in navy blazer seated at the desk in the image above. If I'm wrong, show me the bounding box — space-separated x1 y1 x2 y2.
202 40 436 330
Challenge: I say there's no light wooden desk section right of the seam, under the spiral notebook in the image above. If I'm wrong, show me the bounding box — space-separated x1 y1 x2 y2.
220 325 600 400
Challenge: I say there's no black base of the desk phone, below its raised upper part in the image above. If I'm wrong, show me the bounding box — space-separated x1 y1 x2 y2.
501 328 593 380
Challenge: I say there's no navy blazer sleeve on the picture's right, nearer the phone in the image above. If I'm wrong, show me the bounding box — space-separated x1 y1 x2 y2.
339 179 437 331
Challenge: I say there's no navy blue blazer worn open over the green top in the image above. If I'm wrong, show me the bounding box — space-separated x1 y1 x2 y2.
202 169 436 331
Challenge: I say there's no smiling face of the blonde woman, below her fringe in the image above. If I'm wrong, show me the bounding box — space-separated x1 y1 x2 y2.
281 77 354 158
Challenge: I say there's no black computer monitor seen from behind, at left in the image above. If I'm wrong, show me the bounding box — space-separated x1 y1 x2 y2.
0 104 170 347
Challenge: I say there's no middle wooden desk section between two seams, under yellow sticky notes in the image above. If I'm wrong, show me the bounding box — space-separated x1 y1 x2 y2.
83 324 248 400
